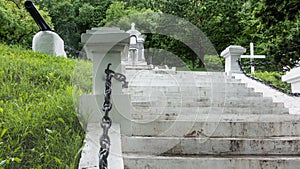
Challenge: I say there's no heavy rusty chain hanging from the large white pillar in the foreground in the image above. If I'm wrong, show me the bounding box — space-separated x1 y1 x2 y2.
99 63 128 169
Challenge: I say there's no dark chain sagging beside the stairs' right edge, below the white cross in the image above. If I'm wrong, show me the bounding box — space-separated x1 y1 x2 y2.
237 59 300 97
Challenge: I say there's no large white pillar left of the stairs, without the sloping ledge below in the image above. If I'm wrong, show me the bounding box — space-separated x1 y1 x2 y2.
80 27 131 133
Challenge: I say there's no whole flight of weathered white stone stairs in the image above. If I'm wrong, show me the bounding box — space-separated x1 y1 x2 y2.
121 70 300 169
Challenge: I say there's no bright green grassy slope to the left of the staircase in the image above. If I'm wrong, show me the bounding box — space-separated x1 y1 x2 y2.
0 45 89 169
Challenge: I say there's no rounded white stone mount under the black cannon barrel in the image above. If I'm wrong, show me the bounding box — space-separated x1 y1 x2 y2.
32 31 67 57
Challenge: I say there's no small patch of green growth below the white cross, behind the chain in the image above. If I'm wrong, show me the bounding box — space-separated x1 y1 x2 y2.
252 71 291 91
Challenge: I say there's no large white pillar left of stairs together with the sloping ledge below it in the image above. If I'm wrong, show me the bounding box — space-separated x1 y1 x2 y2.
79 27 131 169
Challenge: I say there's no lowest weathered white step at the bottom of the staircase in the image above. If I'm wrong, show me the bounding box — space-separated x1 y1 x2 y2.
124 154 300 169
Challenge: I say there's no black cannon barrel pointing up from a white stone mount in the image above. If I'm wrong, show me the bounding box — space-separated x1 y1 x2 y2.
24 0 53 31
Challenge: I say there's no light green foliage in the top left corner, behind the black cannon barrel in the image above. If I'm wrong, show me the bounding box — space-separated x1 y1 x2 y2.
0 0 51 48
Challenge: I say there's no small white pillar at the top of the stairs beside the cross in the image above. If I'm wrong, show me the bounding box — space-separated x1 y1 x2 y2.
221 45 246 76
